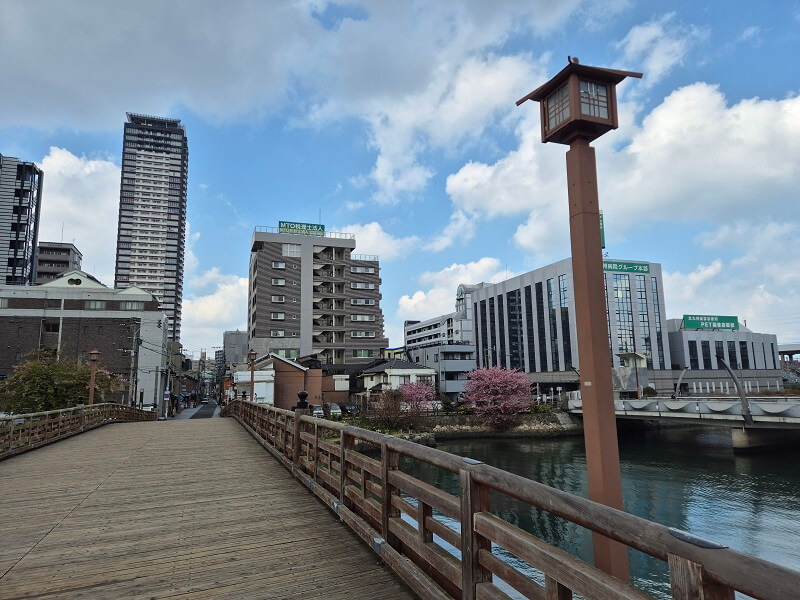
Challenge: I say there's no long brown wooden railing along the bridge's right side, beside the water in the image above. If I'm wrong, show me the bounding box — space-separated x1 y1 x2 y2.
222 401 800 600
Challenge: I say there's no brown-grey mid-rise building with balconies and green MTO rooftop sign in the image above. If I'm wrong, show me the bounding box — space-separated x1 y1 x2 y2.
248 222 387 364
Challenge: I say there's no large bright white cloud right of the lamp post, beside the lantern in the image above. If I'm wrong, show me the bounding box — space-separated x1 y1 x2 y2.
598 83 800 227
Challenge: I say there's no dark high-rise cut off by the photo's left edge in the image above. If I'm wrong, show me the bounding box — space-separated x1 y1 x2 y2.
0 154 43 285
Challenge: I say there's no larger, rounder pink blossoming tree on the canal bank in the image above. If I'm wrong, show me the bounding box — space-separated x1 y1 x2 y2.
461 367 531 429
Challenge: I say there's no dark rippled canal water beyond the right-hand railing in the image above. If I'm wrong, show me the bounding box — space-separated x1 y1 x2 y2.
401 428 800 598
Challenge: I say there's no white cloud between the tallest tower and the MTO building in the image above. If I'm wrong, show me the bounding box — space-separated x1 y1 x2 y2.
181 267 248 354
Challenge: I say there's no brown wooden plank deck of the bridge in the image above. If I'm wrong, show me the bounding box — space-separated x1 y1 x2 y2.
0 419 413 600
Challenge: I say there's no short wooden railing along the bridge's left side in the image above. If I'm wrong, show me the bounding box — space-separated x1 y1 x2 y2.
0 403 156 460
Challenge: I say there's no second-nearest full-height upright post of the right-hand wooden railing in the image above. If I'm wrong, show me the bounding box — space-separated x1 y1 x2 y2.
459 458 492 600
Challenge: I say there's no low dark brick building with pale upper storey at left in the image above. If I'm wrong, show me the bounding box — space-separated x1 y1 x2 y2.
0 270 168 405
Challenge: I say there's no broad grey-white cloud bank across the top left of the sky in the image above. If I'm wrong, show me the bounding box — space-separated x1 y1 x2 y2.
0 0 568 202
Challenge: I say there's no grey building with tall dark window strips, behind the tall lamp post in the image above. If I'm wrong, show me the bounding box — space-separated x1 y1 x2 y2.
473 259 672 393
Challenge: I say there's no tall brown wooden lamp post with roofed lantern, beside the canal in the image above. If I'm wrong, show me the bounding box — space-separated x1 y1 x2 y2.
517 57 642 582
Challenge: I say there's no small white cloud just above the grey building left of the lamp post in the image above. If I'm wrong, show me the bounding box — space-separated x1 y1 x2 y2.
397 256 511 320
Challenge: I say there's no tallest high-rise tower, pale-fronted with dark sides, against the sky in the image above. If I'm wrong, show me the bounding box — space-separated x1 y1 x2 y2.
114 113 189 340
